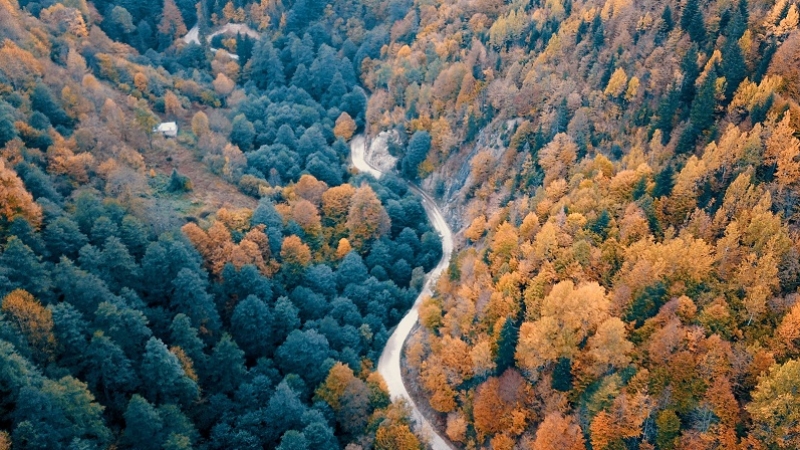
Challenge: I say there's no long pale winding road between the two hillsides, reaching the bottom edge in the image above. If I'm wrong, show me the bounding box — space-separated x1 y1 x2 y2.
350 135 453 450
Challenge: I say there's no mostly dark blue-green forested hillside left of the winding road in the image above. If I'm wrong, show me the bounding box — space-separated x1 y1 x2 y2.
0 0 441 450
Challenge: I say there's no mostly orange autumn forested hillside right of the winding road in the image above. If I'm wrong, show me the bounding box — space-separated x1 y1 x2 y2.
354 0 800 450
